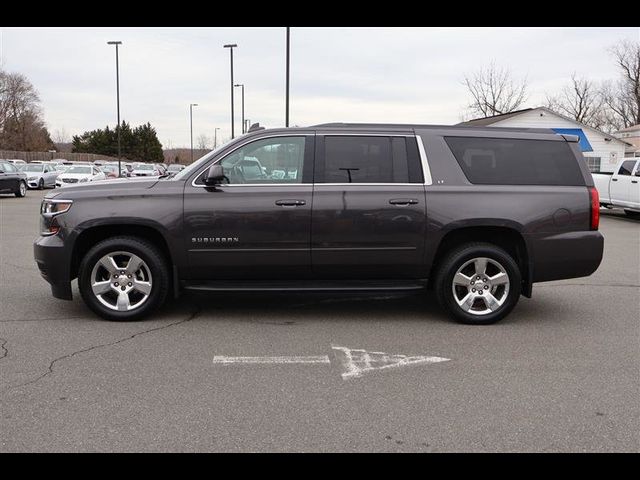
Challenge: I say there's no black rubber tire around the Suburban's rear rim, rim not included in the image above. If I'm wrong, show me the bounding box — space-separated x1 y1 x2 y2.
435 243 522 325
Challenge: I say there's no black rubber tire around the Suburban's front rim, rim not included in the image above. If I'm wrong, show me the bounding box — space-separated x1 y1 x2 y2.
78 236 170 321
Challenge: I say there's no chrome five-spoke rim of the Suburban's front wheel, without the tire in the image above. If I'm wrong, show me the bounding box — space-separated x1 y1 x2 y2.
91 251 152 312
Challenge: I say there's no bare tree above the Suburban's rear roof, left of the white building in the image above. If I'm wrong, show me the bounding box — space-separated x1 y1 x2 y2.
463 63 527 117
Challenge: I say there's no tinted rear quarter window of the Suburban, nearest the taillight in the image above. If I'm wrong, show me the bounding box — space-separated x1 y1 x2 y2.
445 137 585 185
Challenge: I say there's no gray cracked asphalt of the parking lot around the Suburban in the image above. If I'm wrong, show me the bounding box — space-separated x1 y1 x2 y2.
0 191 640 452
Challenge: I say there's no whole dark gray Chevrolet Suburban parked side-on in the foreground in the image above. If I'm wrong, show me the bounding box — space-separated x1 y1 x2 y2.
34 123 604 324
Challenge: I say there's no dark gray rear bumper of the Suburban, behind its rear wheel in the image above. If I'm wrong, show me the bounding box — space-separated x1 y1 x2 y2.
528 231 604 282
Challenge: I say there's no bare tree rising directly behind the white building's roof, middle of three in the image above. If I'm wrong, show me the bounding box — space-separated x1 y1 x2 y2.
546 72 608 128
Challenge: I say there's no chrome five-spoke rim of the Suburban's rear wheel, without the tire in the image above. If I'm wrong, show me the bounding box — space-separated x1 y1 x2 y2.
452 257 509 315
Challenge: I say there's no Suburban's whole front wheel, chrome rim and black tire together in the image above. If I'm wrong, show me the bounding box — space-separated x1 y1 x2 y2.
78 237 169 321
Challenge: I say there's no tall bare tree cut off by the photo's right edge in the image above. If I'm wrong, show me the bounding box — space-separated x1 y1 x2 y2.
601 40 640 130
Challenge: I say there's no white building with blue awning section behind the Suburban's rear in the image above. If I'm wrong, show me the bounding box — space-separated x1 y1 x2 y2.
460 107 629 172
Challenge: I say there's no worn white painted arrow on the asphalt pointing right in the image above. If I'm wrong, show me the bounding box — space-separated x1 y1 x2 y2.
213 345 450 380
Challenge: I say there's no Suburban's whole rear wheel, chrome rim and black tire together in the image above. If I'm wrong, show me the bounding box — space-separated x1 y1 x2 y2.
435 243 521 325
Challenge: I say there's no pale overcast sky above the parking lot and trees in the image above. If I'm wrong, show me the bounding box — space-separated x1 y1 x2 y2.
0 27 640 148
